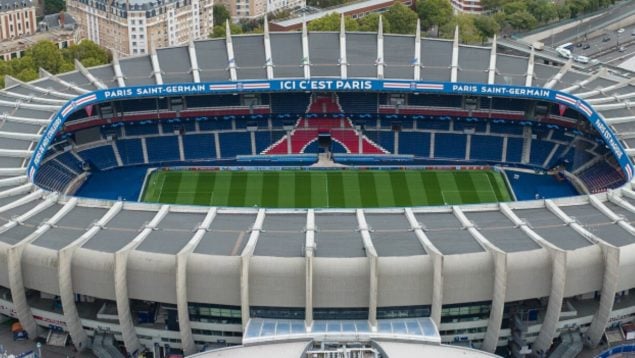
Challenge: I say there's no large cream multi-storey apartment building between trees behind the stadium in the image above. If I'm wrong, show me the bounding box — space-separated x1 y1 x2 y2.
67 0 213 56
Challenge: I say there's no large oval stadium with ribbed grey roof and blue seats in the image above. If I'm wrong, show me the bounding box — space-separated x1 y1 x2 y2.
0 17 635 357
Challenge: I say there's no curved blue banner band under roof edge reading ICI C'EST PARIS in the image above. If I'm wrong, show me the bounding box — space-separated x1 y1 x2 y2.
27 79 633 182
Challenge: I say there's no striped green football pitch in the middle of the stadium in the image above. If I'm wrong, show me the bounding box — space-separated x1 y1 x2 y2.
141 169 511 208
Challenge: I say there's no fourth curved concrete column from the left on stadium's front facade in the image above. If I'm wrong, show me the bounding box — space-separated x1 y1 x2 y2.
175 208 216 355
